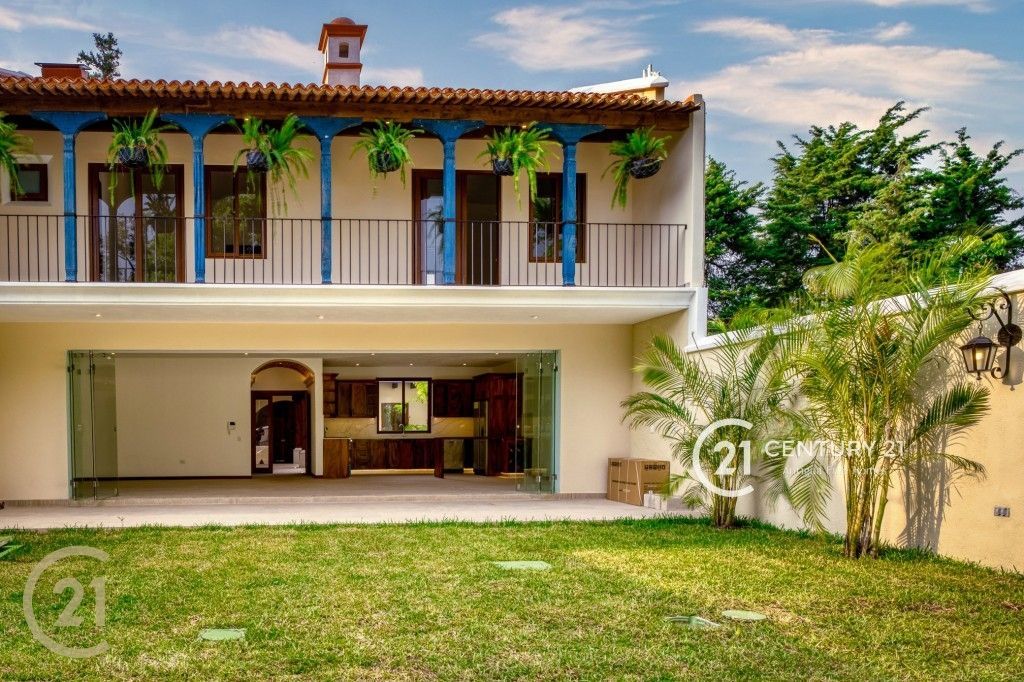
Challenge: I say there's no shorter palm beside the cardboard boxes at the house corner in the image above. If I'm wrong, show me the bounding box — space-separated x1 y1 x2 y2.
622 328 793 528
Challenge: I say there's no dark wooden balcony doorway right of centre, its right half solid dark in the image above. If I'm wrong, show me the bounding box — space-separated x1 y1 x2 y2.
413 170 502 286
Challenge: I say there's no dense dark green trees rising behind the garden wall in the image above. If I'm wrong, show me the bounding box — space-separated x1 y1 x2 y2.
706 102 1024 318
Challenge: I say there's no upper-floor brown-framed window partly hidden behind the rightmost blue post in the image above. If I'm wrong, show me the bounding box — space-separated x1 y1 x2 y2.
529 173 587 263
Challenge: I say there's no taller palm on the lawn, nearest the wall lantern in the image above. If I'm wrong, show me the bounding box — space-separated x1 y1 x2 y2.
765 236 988 557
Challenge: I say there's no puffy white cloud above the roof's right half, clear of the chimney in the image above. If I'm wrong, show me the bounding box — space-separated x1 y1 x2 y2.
473 5 651 71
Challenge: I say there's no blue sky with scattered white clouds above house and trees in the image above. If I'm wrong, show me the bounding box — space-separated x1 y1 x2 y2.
0 0 1024 190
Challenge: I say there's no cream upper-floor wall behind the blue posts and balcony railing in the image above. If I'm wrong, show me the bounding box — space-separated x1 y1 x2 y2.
0 125 703 286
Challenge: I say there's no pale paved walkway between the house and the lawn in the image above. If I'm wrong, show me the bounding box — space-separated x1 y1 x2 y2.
0 496 681 529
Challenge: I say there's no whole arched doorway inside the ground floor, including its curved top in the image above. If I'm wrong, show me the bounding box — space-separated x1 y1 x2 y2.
250 359 316 475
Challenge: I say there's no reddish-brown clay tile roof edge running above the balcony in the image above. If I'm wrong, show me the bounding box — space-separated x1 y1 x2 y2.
0 77 702 127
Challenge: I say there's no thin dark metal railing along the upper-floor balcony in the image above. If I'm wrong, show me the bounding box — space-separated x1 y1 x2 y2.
0 214 689 289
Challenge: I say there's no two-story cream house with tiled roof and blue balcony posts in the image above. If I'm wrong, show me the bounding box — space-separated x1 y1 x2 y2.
0 18 706 501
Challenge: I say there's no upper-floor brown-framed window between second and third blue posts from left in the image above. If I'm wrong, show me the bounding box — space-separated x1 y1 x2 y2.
206 166 266 258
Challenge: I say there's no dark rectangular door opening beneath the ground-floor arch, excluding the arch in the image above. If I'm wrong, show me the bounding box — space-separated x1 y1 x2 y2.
251 391 312 474
